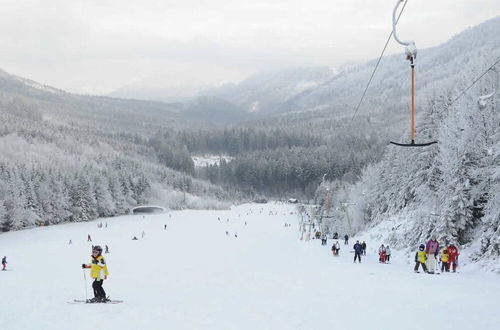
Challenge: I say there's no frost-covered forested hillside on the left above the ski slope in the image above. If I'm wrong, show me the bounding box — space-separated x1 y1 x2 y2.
0 68 232 231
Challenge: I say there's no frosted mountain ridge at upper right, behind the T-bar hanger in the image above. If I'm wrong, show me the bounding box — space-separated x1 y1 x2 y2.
281 17 500 114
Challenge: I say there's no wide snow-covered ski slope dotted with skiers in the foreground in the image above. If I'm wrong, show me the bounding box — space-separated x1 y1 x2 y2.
0 204 500 330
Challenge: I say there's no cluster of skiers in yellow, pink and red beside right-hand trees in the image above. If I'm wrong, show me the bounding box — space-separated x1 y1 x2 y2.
414 236 459 274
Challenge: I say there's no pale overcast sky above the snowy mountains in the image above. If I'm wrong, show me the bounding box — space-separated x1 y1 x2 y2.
0 0 500 93
